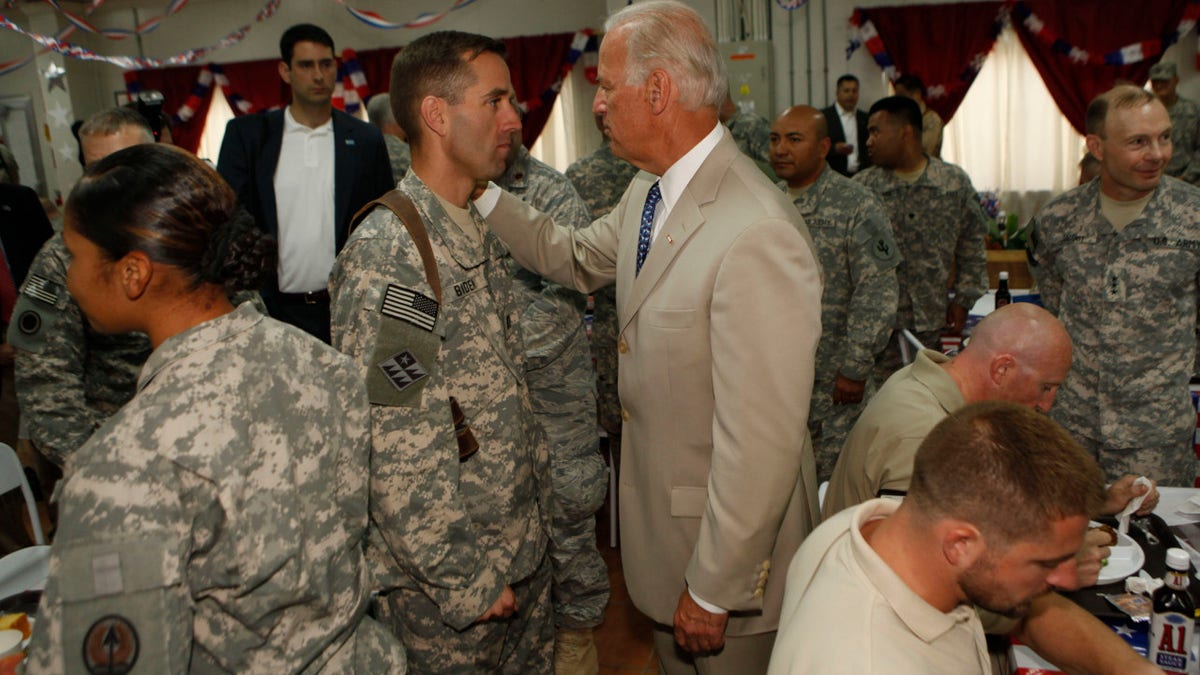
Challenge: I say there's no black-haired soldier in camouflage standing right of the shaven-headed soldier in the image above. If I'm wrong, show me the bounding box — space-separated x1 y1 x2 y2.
854 96 988 383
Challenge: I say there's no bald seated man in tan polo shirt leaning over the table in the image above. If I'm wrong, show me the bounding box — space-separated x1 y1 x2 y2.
822 303 1158 576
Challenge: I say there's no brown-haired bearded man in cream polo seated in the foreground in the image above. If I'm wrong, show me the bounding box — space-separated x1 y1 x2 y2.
769 401 1158 675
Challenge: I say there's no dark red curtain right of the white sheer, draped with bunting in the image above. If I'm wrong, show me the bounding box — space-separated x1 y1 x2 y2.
1013 0 1188 133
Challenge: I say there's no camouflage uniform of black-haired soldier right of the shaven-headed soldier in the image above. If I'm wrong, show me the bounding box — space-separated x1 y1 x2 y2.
853 155 988 384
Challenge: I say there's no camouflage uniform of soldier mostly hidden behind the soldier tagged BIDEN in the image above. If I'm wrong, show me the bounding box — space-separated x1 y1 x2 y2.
496 147 608 628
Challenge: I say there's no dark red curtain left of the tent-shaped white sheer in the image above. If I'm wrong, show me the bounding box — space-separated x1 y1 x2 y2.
859 1 1004 121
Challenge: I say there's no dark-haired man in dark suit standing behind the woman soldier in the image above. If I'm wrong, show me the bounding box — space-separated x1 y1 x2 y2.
217 24 396 342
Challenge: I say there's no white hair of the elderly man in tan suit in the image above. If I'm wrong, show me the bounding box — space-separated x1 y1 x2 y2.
605 0 728 109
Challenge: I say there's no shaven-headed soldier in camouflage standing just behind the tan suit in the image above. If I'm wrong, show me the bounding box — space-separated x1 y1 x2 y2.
770 106 900 482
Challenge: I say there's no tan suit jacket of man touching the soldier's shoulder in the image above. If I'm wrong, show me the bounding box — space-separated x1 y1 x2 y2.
487 132 821 635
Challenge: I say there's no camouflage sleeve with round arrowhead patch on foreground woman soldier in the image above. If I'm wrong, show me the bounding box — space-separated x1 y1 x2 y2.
26 441 193 674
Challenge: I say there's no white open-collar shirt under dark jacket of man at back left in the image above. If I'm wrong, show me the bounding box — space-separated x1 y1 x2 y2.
275 106 336 293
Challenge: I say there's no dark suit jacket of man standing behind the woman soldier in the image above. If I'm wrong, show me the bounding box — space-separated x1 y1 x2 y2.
217 109 396 251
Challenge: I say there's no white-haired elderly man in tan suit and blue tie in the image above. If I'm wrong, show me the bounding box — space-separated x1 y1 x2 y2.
476 1 821 673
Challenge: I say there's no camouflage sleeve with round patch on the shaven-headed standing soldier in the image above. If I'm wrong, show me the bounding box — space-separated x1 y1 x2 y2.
838 196 901 381
